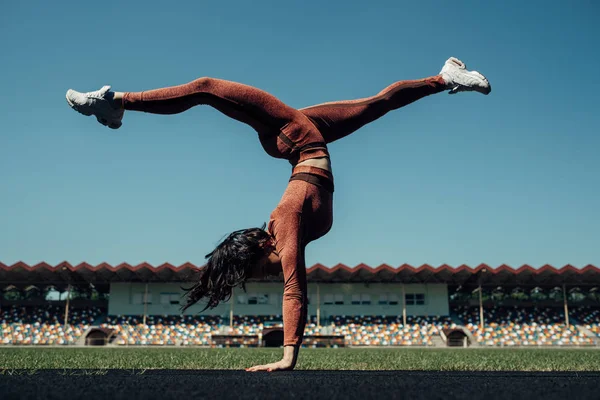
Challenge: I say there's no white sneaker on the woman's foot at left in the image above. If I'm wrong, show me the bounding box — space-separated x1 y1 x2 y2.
66 86 124 129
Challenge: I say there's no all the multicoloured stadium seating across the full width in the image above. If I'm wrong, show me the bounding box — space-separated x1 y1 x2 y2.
0 306 600 346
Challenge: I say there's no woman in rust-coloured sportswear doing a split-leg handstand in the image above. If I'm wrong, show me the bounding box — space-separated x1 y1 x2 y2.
66 58 491 371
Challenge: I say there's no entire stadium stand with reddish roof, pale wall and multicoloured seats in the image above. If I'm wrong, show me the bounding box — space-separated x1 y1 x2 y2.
0 262 600 347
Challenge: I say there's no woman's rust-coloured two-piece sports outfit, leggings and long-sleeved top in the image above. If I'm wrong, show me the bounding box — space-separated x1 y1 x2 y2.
123 76 446 346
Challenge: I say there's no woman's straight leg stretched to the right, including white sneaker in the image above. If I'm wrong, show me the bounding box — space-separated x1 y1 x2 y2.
300 58 491 143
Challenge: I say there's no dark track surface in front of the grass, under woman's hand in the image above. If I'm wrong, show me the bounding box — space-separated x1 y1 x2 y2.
0 370 600 400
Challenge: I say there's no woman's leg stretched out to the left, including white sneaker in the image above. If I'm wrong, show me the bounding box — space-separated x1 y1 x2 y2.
67 78 301 134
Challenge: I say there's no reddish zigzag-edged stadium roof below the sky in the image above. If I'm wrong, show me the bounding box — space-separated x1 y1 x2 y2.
0 262 600 287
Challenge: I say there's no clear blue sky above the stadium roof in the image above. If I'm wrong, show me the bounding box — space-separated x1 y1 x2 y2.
0 0 600 267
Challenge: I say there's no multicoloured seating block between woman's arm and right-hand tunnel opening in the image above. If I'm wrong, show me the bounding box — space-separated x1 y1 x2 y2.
332 316 454 346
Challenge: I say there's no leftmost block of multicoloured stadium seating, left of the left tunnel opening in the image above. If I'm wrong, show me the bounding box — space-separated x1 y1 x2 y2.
0 306 101 345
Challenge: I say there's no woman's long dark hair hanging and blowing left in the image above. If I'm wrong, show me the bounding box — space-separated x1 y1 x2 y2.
181 224 273 312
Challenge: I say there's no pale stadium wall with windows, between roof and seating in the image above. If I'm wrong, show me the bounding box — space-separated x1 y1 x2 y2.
108 282 449 318
